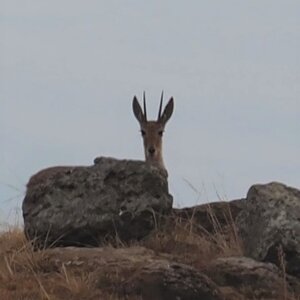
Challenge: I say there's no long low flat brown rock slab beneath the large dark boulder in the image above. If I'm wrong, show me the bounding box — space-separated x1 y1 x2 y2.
44 247 223 300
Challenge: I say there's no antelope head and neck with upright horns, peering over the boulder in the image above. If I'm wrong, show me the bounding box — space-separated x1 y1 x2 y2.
132 92 174 170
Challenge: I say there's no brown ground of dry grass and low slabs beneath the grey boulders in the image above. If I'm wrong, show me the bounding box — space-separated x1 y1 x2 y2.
0 200 300 300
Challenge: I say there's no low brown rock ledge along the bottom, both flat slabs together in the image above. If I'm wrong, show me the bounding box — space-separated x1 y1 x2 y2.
34 246 300 300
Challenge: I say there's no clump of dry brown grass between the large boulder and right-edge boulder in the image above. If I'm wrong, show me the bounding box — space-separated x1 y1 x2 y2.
141 205 243 269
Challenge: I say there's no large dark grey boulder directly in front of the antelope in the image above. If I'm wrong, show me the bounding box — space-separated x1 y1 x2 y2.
22 157 172 247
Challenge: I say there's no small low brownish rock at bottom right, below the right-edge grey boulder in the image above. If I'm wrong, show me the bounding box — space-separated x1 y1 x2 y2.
206 257 300 300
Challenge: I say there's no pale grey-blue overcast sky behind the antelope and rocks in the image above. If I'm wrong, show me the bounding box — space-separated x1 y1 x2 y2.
0 0 300 224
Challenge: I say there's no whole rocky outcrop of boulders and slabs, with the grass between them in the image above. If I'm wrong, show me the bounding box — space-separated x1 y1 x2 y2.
21 169 300 300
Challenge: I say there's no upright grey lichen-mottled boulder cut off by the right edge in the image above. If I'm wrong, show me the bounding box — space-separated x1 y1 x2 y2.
236 182 300 277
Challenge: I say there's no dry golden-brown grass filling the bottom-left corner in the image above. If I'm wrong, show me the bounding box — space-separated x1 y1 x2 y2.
0 229 119 300
